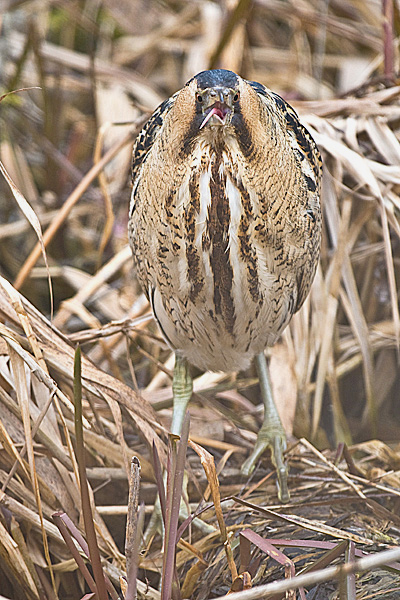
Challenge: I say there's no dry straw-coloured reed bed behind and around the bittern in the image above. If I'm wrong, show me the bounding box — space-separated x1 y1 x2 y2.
0 0 400 600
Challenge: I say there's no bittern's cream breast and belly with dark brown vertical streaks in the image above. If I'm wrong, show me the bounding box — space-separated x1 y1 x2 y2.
144 146 306 371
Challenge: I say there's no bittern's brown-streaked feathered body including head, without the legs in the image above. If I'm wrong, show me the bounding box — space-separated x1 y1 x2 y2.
129 70 321 500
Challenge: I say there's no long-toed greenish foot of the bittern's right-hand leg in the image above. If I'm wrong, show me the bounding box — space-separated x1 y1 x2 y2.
241 424 290 503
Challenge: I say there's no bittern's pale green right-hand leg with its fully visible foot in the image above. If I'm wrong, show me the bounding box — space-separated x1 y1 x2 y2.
242 352 290 502
